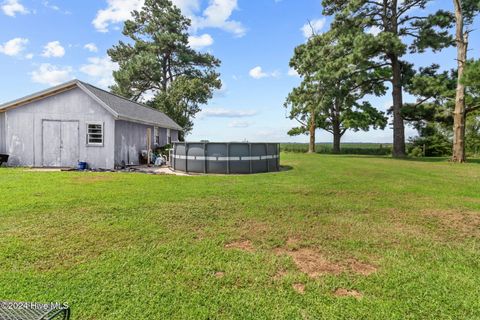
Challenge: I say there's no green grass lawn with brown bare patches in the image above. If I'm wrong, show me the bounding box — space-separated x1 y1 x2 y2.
0 153 480 320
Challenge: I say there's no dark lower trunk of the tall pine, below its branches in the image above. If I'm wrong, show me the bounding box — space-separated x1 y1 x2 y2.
390 55 406 158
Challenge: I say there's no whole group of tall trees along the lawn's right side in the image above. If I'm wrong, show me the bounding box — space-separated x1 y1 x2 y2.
285 0 480 162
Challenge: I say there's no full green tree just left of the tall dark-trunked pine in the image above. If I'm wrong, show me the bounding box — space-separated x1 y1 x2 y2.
285 29 387 153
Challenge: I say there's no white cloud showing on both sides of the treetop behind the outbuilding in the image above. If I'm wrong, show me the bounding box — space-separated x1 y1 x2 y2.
92 0 246 37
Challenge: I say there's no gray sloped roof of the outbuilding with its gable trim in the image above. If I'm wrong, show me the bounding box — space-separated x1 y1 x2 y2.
0 80 182 130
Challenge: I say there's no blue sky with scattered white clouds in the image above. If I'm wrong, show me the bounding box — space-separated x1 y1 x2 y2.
0 0 480 143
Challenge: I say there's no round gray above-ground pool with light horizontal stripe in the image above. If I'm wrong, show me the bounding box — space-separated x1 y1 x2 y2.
171 142 280 174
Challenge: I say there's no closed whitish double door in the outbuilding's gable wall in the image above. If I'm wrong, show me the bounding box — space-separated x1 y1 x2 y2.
42 120 79 167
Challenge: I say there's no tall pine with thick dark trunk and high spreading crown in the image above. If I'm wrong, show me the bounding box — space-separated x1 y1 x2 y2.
322 0 452 157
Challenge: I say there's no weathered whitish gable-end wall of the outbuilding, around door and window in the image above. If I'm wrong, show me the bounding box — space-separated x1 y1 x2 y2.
5 88 115 169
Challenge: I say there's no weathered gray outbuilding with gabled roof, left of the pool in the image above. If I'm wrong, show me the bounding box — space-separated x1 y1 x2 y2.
0 80 182 169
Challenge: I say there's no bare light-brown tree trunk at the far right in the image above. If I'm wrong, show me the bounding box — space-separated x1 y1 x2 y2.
452 0 468 163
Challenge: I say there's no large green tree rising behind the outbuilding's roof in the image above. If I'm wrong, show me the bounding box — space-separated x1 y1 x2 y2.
108 0 221 133
